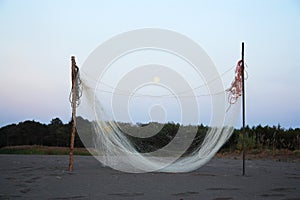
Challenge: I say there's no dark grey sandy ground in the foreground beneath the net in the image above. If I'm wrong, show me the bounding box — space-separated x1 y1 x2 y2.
0 155 300 200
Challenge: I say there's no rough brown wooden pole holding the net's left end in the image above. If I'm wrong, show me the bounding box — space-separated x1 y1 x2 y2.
69 56 76 172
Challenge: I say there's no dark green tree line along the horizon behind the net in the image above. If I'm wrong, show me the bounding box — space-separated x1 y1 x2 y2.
0 118 300 153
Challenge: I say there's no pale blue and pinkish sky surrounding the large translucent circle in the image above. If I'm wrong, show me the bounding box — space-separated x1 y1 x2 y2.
0 0 300 128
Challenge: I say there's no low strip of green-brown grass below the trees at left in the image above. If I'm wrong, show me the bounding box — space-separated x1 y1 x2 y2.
0 145 91 156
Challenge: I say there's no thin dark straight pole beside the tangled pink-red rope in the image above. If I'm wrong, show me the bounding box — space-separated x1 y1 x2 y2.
242 42 246 176
